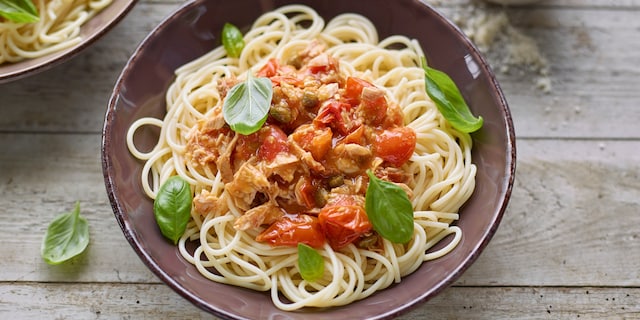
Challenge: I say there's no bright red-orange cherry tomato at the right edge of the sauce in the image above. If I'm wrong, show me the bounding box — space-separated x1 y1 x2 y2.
373 127 416 167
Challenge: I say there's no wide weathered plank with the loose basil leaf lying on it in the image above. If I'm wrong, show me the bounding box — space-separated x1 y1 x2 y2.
0 134 640 286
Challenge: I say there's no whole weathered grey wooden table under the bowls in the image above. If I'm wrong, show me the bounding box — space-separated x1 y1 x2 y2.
0 0 640 319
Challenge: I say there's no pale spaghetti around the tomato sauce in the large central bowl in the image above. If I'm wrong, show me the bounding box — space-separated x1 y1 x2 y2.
127 5 476 310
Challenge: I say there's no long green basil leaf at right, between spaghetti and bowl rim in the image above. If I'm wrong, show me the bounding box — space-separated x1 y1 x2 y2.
422 57 483 133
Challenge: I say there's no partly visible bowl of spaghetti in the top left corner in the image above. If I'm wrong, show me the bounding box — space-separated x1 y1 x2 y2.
0 0 136 83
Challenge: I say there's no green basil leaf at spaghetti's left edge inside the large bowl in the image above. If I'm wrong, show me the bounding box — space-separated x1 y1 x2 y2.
153 176 192 244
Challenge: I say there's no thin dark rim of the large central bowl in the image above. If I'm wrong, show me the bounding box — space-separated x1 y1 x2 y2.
101 0 517 319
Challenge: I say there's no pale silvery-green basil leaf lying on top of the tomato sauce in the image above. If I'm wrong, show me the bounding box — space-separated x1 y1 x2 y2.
222 72 273 135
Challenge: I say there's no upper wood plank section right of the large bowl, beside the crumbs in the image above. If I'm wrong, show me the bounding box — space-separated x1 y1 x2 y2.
498 10 640 139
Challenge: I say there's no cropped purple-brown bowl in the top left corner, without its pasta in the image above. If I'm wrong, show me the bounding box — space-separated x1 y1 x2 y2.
0 0 137 84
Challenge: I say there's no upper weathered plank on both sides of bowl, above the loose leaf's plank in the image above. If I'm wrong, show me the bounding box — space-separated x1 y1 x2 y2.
0 1 640 139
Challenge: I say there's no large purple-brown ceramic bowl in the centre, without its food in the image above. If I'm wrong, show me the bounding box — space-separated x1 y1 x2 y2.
102 0 516 320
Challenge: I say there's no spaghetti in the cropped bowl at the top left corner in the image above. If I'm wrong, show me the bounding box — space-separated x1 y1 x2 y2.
0 0 112 64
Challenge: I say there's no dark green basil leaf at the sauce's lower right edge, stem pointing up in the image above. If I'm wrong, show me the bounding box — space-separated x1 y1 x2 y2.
364 170 413 243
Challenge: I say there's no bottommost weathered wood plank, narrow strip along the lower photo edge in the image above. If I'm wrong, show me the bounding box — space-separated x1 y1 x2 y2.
0 283 640 320
